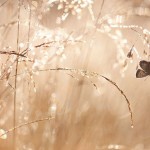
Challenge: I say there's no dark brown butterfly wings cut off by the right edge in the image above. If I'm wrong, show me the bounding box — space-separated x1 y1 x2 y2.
136 60 150 78
